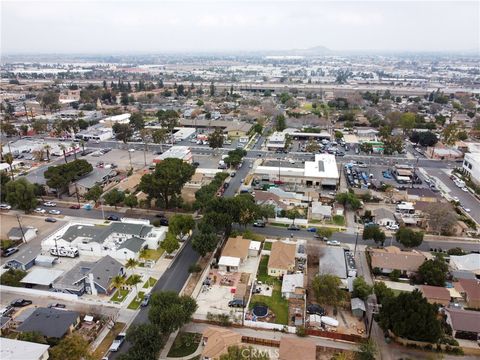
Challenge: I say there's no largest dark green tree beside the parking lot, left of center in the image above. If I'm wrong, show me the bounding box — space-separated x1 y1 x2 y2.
139 158 195 208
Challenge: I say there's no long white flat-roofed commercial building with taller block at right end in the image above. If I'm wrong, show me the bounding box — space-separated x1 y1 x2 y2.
254 154 340 188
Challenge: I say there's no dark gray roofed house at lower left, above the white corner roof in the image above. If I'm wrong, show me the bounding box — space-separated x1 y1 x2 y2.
17 308 80 339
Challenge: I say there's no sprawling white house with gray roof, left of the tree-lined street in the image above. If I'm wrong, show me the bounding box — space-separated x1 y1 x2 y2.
42 220 168 260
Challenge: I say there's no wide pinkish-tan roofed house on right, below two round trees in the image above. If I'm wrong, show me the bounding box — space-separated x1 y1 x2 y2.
369 246 427 276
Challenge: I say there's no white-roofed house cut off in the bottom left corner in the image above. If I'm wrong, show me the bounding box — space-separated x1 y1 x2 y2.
0 337 50 360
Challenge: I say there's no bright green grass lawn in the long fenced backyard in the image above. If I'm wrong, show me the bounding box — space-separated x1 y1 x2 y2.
249 255 288 325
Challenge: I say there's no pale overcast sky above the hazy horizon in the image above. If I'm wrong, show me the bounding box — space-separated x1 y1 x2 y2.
1 0 480 54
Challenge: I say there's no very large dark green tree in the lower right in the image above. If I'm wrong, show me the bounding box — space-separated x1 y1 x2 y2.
378 290 442 343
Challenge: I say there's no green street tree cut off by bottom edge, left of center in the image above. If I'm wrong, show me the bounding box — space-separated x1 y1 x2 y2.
120 323 166 360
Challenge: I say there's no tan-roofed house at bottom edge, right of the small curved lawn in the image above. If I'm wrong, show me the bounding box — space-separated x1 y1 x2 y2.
202 327 242 360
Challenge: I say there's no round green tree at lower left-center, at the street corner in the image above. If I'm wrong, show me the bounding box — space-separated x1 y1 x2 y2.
148 291 197 334
